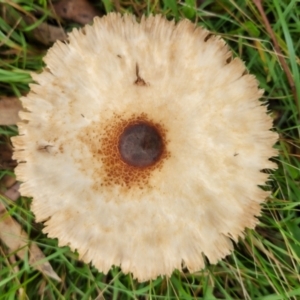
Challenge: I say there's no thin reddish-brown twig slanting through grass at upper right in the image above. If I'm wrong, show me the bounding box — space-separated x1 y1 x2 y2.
253 0 300 112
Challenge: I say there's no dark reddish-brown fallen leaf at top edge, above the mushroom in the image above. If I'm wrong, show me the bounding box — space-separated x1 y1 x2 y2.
53 0 101 25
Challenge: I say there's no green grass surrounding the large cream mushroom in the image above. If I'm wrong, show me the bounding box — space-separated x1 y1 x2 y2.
0 0 300 300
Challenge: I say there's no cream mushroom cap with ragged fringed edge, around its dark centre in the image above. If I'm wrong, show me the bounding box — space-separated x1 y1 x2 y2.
13 13 277 281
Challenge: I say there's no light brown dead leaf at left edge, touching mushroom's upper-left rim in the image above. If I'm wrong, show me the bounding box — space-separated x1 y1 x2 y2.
0 97 22 125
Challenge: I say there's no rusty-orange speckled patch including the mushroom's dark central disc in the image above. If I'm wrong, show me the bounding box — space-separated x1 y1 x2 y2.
79 114 170 189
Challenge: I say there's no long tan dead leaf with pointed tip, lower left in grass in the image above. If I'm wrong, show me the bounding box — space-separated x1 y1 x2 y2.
0 203 61 282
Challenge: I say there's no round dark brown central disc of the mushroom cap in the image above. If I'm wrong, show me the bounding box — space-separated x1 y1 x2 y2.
118 122 163 168
